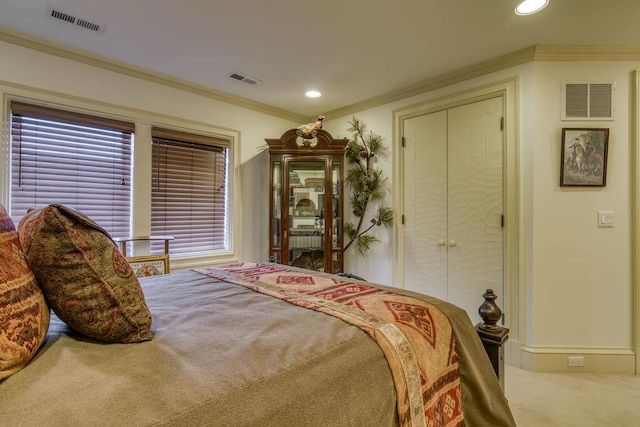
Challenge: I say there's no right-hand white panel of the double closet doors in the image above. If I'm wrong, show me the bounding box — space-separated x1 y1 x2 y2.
448 98 503 323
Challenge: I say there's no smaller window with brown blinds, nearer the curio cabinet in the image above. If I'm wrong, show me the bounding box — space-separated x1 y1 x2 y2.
151 128 230 255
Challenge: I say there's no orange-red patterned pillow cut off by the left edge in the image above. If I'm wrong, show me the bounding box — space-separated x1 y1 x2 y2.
0 205 49 379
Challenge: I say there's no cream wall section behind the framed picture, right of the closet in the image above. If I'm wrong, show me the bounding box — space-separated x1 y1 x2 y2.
521 62 640 360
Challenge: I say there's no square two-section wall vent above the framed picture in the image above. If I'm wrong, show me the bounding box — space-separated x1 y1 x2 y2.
561 82 616 120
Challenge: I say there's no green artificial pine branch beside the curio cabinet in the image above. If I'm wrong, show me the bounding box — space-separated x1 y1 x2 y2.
344 116 393 255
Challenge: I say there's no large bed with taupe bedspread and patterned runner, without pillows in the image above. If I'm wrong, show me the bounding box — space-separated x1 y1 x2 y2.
0 206 515 426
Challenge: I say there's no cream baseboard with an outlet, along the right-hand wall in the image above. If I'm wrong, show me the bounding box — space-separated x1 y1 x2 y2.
505 340 638 375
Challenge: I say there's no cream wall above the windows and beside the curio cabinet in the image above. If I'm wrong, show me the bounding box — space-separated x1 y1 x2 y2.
0 42 296 268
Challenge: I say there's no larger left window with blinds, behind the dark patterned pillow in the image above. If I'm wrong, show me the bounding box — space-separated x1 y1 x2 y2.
10 102 134 236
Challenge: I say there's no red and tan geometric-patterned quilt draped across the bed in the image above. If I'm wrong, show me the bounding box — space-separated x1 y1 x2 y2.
195 263 465 426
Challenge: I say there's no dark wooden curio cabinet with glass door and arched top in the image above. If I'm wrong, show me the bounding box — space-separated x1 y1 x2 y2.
266 129 348 273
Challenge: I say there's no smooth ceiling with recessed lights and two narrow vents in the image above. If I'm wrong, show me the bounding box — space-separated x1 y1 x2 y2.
0 0 640 119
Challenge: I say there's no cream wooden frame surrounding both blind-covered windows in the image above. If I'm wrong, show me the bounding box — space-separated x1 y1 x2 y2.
0 92 242 270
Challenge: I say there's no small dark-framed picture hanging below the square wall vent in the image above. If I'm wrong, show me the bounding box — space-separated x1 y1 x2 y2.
560 128 609 187
